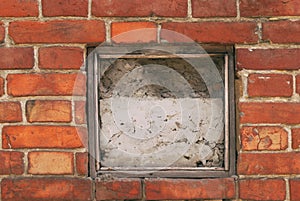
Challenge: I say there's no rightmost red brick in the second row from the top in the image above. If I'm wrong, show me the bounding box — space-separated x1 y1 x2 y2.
262 21 300 43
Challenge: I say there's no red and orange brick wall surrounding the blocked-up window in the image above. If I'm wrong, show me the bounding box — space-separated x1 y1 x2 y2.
0 0 300 201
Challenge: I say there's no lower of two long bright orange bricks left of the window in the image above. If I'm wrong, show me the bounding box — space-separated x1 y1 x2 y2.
2 126 87 149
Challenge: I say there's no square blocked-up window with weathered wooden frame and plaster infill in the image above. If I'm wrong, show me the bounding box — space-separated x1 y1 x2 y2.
87 44 235 177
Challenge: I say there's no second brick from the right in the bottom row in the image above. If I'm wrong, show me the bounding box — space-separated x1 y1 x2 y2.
239 179 286 200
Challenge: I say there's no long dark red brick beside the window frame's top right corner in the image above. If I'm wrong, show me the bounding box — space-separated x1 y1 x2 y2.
236 49 300 70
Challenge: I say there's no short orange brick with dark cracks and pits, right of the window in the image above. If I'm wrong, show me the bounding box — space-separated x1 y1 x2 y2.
240 126 288 151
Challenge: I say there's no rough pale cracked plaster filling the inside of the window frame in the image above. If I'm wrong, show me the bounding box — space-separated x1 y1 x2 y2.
99 59 224 168
